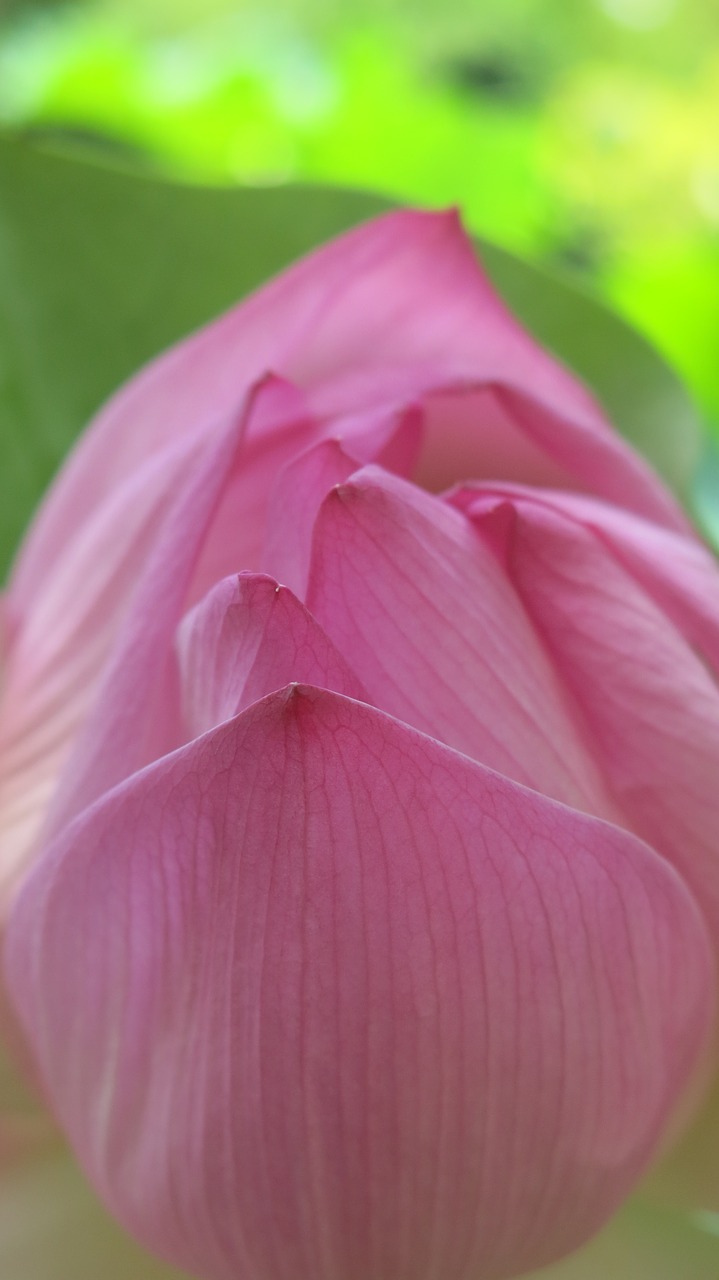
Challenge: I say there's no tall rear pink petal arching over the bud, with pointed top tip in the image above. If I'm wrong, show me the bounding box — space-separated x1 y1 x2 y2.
14 212 682 609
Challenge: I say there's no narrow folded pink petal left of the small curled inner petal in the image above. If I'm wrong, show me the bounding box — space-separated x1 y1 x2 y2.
37 379 319 855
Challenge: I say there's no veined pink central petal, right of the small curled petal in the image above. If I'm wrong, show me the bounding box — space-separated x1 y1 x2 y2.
307 467 615 815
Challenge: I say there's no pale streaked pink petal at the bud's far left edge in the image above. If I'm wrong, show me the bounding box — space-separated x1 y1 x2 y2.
0 432 204 915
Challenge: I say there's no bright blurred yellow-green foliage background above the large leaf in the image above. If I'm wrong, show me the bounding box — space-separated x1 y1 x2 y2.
0 0 719 430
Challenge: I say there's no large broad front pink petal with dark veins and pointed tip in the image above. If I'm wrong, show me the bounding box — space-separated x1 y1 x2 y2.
8 686 714 1280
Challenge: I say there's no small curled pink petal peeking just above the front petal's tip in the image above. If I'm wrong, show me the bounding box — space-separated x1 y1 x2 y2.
178 573 366 737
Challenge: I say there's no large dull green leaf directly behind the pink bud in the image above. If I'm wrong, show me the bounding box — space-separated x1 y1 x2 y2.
0 138 697 568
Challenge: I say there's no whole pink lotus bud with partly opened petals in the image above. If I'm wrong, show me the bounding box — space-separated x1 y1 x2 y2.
0 214 719 1280
